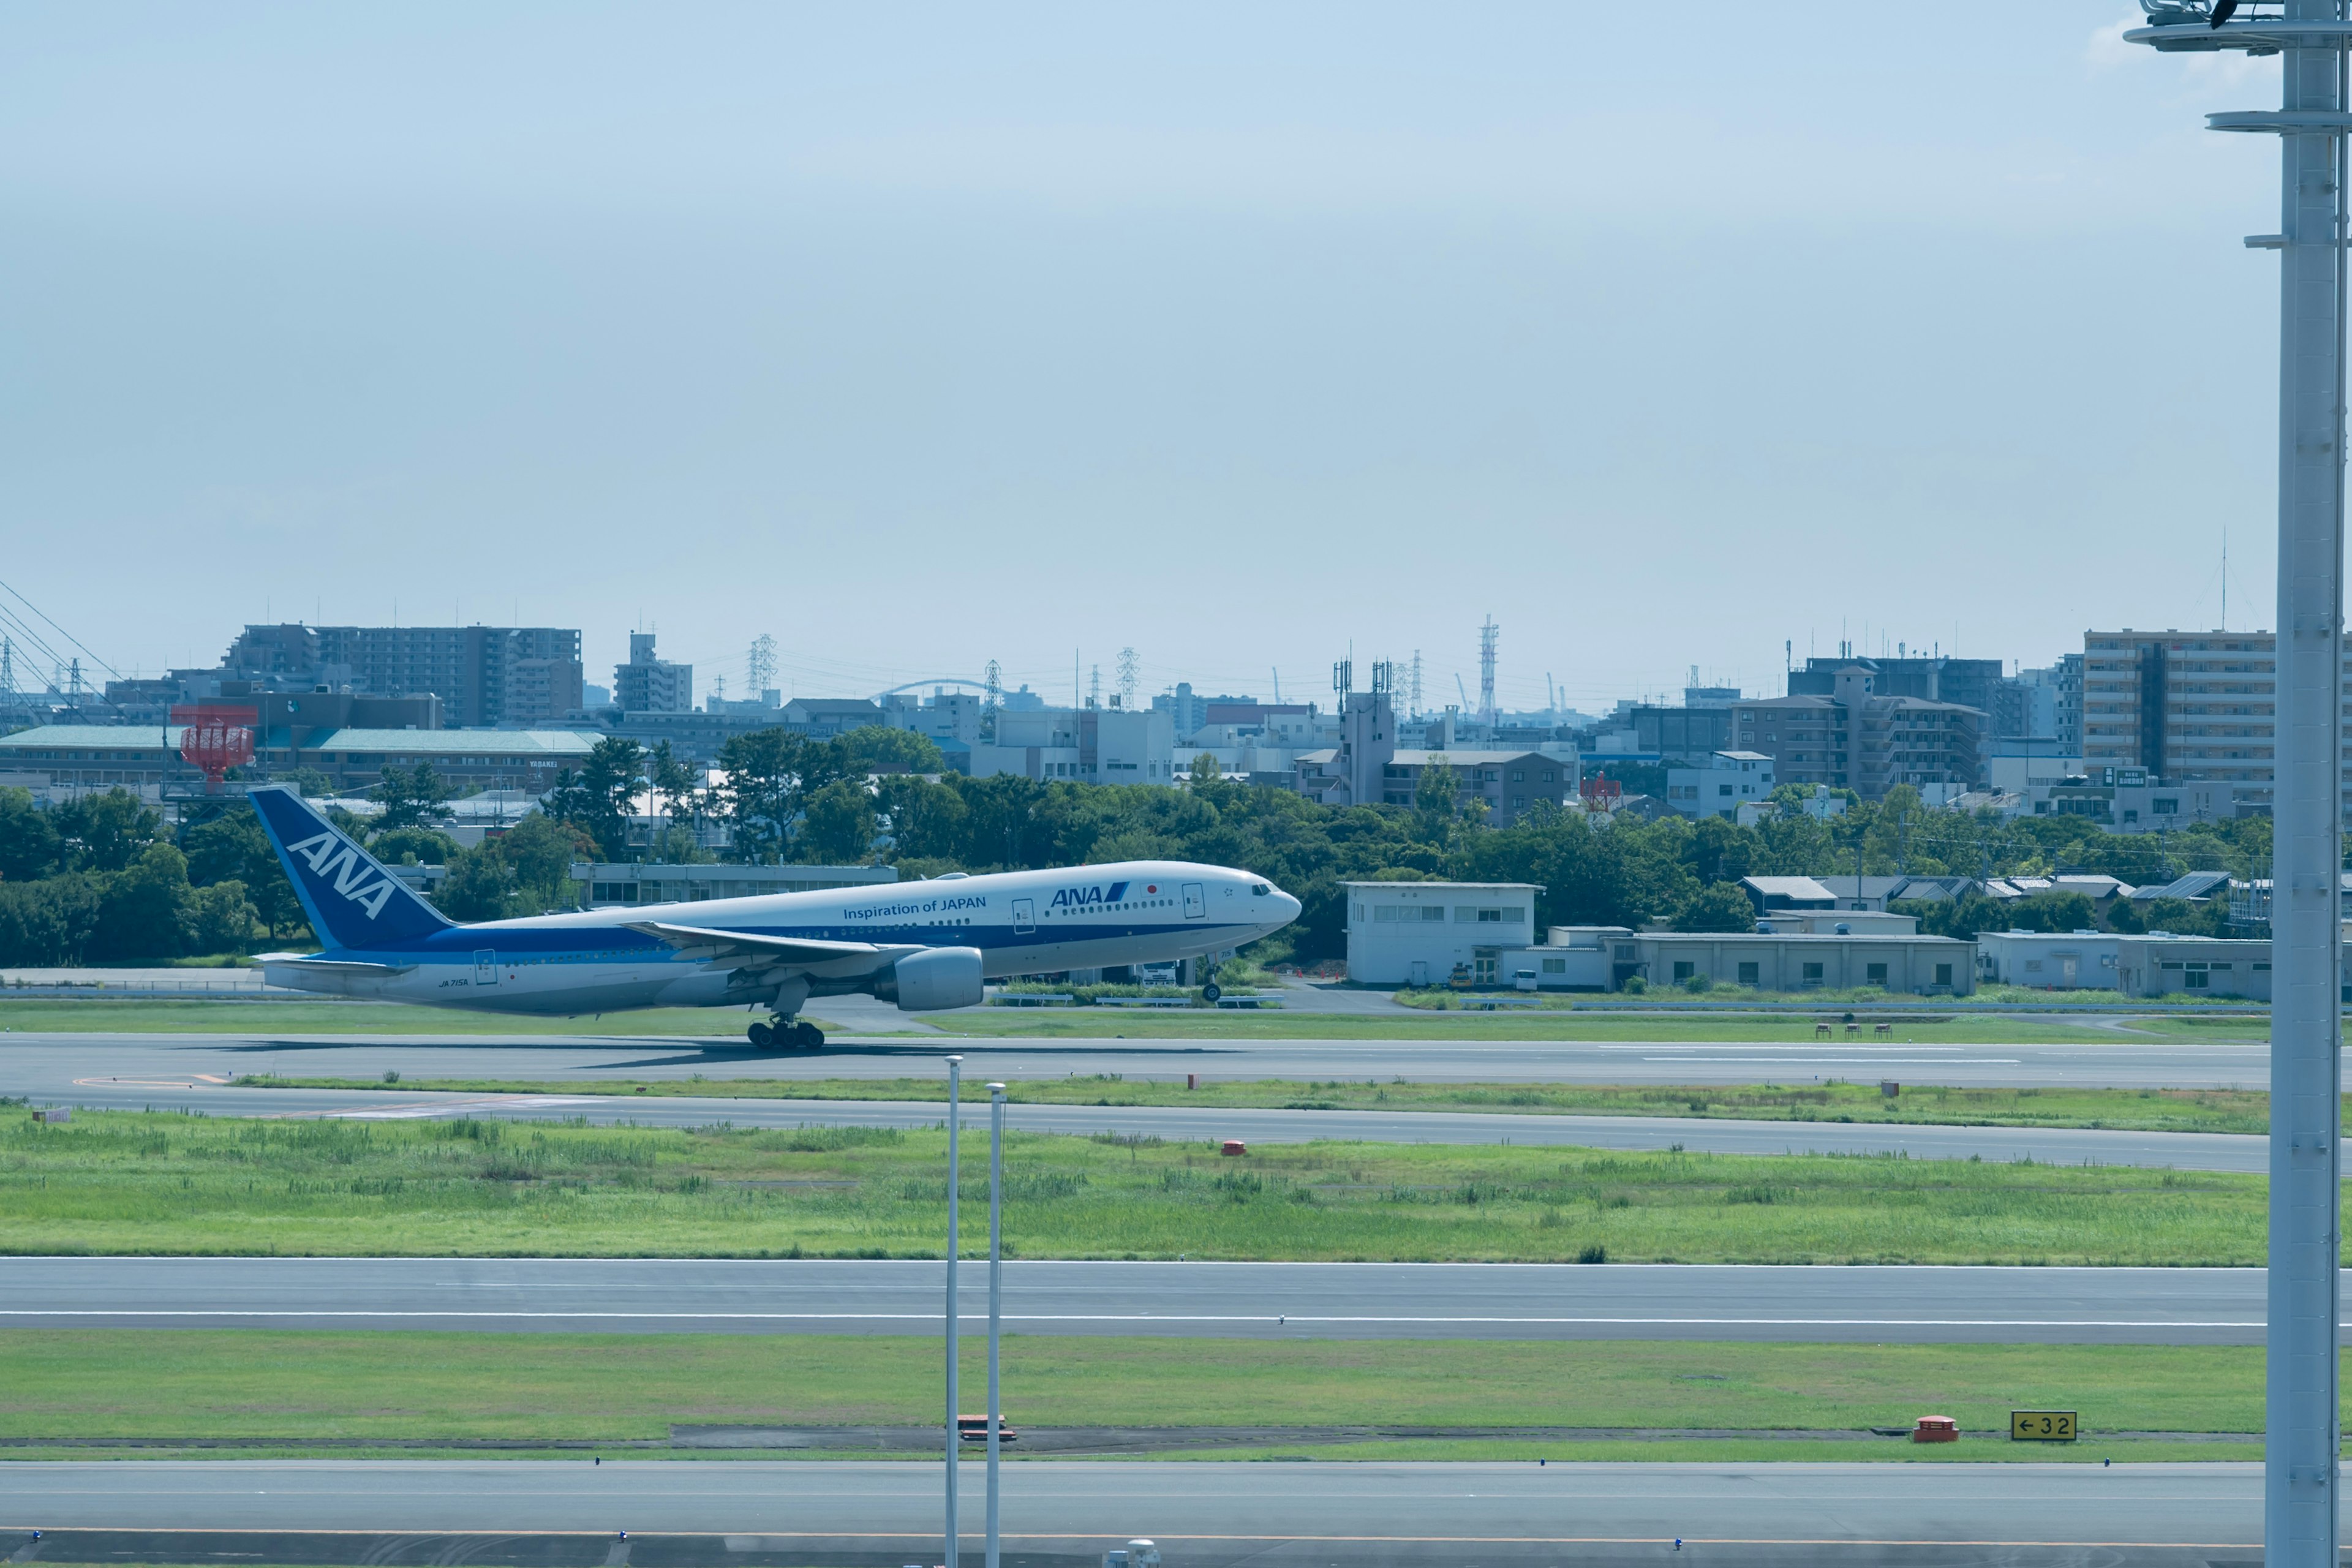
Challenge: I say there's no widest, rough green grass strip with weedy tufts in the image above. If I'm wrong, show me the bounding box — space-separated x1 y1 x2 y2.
0 1112 2265 1267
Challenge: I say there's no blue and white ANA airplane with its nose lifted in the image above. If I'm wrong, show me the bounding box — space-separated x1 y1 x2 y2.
249 785 1298 1051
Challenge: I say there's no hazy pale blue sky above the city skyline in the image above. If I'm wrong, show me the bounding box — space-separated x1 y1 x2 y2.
0 0 2305 705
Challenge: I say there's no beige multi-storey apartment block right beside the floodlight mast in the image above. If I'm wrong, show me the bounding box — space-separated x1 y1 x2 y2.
2081 628 2352 813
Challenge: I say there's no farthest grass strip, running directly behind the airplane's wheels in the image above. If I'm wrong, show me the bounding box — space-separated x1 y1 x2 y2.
0 997 2270 1044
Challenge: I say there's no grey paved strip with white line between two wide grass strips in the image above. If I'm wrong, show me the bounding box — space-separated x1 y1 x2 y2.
0 1257 2263 1344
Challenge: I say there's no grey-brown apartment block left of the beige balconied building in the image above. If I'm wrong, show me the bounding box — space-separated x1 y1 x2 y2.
1731 661 1990 799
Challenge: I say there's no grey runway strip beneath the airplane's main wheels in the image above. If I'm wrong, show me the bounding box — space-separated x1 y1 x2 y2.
0 1020 2270 1096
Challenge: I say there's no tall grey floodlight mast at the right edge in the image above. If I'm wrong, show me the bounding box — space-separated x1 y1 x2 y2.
2124 0 2352 1568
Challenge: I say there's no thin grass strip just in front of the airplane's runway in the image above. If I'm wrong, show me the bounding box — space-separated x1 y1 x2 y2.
238 1074 2270 1133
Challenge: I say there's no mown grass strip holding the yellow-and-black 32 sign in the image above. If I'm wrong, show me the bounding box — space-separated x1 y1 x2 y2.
0 1329 2295 1460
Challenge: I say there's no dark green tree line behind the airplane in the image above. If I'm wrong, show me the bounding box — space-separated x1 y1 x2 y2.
0 726 2270 964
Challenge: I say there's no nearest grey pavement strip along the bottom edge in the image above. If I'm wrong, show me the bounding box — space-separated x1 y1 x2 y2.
0 1460 2263 1568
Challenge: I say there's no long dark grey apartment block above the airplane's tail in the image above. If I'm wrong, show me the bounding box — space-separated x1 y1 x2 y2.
192 623 581 729
